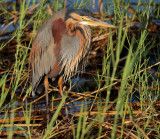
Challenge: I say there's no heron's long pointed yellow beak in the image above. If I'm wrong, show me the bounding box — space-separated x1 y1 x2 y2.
79 16 116 28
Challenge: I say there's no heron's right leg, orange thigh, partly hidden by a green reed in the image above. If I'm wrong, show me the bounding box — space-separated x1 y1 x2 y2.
58 76 68 119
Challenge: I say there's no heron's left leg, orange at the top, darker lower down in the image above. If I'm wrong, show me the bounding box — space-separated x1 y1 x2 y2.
44 76 49 121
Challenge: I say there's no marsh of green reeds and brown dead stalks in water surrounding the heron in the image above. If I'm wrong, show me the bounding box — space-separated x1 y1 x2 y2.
0 0 160 139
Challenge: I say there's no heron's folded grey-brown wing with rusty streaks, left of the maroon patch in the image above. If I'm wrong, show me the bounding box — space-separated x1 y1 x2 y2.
30 10 66 93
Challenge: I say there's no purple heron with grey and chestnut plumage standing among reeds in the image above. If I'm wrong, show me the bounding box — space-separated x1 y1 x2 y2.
29 9 115 117
